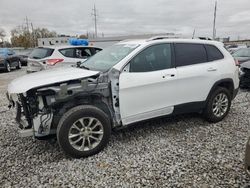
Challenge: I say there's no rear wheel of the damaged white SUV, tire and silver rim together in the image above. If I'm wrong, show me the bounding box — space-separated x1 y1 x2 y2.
203 87 232 123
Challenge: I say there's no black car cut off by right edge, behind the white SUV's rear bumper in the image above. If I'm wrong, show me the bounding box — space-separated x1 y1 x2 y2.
240 61 250 89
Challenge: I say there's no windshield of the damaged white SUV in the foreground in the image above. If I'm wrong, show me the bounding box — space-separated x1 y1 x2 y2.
80 44 139 72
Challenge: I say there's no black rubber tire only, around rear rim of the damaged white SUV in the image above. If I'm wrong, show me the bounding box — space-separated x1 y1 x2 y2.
203 87 232 123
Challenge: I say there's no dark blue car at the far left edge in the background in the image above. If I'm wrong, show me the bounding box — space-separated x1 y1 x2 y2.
0 48 22 72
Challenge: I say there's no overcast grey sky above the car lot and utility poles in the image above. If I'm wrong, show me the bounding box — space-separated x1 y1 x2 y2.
0 0 250 39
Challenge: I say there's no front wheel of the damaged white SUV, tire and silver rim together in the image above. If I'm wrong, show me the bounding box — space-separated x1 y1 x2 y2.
57 105 111 158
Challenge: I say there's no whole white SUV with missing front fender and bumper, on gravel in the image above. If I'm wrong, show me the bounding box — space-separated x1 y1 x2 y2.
7 37 239 158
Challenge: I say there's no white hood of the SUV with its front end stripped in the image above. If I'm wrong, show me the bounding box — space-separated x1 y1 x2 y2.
8 67 99 94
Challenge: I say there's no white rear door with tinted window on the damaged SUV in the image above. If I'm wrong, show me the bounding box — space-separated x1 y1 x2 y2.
174 43 218 104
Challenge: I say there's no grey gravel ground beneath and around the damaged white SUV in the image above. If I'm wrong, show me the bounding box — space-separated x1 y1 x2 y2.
0 69 250 187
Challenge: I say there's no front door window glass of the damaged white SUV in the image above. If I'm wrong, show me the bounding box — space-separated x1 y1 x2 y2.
130 44 172 72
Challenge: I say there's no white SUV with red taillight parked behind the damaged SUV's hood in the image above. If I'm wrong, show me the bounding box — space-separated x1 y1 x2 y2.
27 46 102 73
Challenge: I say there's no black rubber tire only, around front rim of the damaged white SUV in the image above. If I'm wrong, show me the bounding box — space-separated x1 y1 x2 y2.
57 105 111 158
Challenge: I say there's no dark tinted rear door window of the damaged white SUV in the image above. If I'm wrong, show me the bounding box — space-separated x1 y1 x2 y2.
174 43 207 67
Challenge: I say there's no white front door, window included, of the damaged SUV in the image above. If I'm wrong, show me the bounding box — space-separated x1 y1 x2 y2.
119 44 178 125
